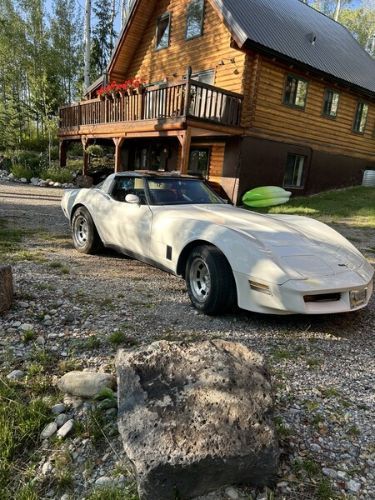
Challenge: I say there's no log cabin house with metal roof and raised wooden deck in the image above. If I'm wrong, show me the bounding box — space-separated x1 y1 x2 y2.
59 0 375 202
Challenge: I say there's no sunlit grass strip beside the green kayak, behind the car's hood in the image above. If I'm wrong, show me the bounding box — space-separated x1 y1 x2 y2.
251 186 375 228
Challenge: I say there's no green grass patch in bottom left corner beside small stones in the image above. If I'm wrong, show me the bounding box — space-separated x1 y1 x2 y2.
0 377 51 498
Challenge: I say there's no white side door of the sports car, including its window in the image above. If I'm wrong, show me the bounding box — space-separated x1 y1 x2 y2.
106 176 152 257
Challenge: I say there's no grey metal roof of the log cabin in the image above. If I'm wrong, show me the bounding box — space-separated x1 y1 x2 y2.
210 0 375 92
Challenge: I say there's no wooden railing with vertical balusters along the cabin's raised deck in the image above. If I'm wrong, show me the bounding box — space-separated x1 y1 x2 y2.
60 80 243 129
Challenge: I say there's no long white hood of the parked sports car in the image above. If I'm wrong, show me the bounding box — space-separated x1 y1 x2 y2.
153 205 370 278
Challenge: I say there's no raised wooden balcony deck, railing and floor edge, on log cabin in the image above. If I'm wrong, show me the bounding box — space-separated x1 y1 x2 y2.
59 80 243 139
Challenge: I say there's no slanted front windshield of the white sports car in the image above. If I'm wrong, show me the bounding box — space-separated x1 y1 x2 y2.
147 178 224 205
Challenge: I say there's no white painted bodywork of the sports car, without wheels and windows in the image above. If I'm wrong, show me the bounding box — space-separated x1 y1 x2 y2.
62 173 374 314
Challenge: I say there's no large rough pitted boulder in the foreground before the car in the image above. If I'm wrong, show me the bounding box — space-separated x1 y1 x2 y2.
116 340 279 500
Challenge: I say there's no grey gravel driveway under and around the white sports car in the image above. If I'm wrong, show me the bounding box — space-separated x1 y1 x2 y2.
0 182 375 499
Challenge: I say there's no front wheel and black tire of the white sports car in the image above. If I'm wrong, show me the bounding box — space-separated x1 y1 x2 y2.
185 245 237 315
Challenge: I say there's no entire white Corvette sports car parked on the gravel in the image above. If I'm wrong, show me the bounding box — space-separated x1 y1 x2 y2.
62 172 374 314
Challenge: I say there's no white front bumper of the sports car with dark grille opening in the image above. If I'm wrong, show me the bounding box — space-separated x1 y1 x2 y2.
234 266 374 314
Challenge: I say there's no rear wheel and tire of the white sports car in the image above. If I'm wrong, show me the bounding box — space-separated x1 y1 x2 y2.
71 207 103 254
